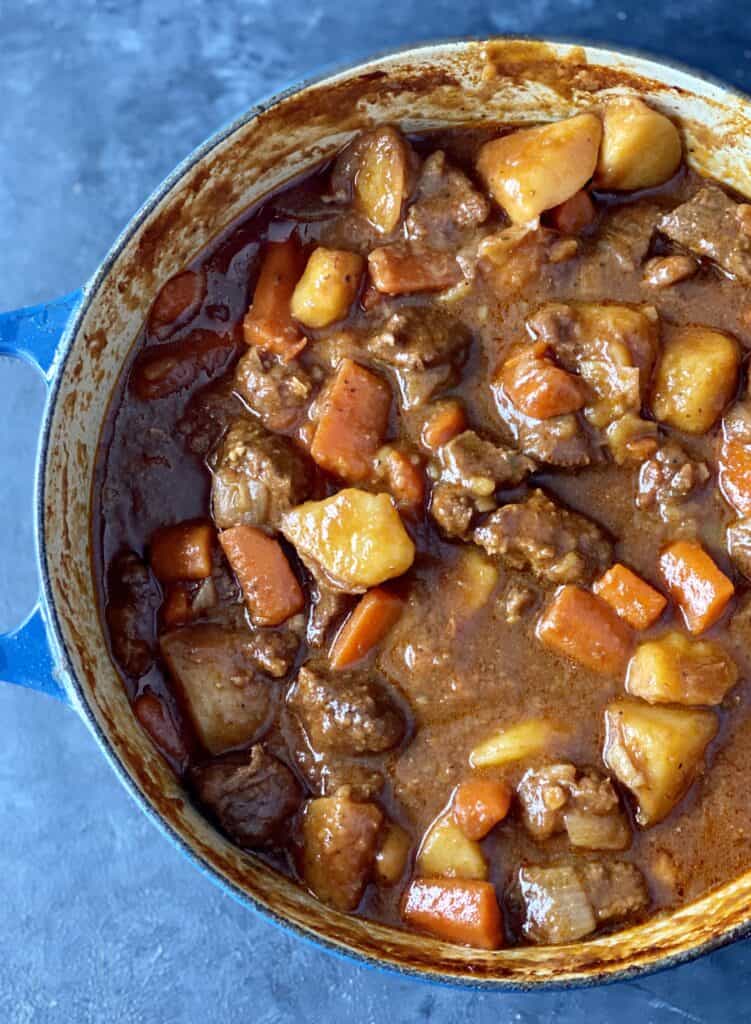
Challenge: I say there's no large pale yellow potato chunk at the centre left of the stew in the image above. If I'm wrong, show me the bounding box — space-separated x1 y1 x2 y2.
282 487 415 594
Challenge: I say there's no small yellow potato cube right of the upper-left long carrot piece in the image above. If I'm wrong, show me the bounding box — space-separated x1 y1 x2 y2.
290 246 365 328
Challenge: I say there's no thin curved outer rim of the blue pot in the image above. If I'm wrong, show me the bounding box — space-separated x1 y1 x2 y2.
34 34 751 991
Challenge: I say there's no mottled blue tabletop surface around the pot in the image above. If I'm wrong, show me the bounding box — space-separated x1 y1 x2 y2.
0 0 751 1024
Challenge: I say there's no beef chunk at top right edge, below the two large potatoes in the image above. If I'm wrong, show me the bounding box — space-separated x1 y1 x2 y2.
658 185 751 285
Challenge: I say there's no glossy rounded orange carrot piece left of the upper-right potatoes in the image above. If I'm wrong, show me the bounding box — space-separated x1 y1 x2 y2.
500 342 587 420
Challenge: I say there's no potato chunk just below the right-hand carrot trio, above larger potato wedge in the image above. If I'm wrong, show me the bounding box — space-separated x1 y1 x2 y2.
626 630 738 705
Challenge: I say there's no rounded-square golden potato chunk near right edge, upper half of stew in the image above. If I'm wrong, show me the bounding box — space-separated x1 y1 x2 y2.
652 324 741 434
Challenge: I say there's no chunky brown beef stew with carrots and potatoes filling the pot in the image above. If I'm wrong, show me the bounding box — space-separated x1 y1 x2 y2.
97 105 751 949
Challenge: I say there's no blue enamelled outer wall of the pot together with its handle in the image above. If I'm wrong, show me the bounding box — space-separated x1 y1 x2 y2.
7 39 751 990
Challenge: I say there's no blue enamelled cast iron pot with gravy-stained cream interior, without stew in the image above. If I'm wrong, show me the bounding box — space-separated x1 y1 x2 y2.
0 39 751 989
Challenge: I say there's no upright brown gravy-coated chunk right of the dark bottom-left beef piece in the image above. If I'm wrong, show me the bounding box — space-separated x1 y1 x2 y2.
301 787 383 910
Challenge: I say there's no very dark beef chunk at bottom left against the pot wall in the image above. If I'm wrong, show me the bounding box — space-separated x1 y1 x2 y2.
193 743 302 850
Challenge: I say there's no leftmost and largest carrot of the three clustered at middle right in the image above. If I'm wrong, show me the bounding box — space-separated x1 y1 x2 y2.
537 584 633 676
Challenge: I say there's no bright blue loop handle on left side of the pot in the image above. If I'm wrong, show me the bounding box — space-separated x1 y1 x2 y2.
0 290 83 701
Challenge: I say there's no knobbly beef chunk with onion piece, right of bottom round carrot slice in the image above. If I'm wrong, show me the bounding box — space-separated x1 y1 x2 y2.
517 764 631 850
